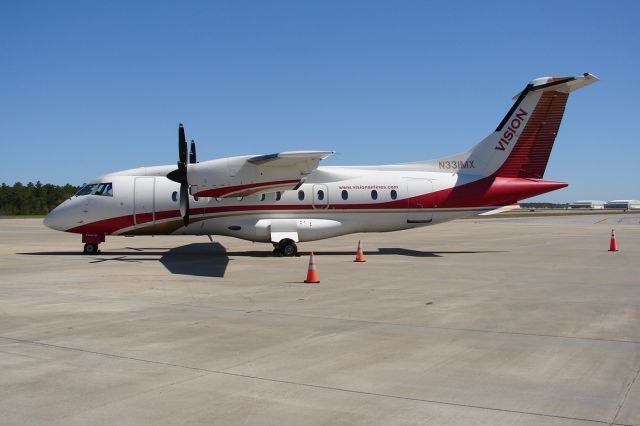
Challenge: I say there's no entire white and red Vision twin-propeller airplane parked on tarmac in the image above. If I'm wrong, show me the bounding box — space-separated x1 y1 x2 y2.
44 73 599 256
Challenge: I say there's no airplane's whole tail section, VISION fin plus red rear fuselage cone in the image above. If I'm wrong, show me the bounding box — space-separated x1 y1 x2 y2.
422 73 598 207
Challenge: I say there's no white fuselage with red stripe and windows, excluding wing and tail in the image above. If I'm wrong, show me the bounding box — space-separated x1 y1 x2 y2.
47 166 498 242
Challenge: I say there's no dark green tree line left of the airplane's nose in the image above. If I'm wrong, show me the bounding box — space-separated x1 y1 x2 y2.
0 181 80 216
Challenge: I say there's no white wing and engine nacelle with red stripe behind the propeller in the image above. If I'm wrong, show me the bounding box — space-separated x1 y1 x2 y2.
188 151 335 197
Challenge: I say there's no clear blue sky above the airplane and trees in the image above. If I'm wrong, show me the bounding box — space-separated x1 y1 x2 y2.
0 0 640 201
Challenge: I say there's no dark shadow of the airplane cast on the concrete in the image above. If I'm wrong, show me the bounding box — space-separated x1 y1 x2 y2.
16 242 502 278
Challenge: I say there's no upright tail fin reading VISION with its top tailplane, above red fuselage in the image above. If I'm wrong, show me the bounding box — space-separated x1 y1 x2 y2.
429 73 598 179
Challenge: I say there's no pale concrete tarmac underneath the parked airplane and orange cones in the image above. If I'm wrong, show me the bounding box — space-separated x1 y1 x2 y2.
0 214 640 425
